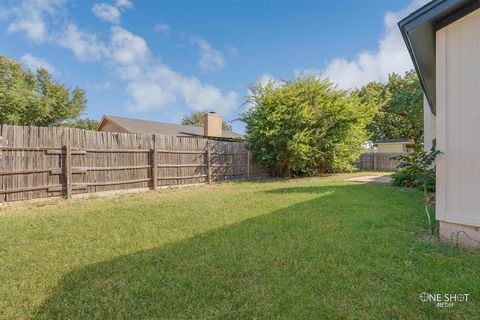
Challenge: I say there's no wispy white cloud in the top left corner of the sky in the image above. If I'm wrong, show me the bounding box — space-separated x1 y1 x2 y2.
3 0 65 42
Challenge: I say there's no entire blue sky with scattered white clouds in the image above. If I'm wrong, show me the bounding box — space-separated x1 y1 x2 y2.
0 0 425 132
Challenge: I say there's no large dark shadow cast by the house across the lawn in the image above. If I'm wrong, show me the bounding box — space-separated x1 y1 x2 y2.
36 185 480 319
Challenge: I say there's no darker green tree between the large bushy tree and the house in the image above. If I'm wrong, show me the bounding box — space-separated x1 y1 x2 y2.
354 70 423 141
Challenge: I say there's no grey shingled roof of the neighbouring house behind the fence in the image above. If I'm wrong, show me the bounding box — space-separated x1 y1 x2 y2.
97 115 242 139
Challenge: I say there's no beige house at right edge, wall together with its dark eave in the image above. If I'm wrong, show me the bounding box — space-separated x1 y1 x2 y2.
399 0 480 246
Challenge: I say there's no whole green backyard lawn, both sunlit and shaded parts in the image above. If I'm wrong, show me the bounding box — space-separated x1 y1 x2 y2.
0 176 480 319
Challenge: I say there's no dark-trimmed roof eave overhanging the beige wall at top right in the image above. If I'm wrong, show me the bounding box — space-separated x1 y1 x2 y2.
398 0 480 114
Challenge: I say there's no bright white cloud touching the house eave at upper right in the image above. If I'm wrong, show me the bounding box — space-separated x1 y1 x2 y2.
294 0 428 89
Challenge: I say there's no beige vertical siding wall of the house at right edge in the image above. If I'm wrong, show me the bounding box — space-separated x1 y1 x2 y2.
436 10 480 238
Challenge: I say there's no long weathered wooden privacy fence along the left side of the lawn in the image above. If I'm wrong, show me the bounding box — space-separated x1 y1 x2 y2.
0 125 267 201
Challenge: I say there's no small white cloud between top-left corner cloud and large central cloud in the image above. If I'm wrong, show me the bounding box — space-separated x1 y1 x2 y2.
55 23 107 61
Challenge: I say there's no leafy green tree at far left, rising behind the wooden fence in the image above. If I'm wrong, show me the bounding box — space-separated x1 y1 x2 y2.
0 55 87 126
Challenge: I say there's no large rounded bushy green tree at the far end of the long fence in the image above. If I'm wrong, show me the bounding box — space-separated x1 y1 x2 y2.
241 78 375 176
